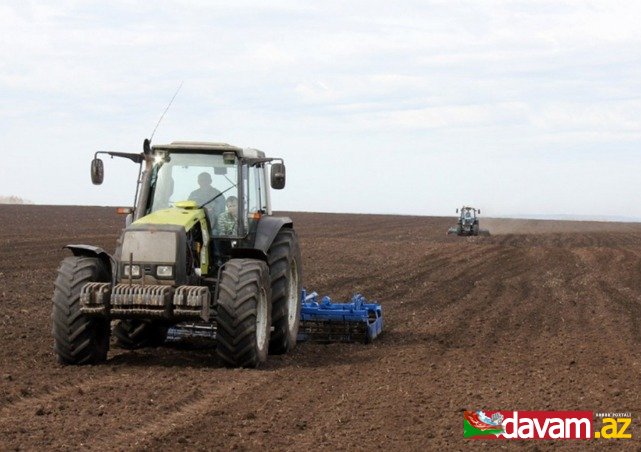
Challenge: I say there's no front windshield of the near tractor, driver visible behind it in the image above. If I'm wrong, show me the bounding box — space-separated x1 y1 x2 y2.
148 152 238 236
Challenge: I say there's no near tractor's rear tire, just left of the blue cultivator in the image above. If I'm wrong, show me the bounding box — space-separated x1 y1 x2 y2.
267 229 303 355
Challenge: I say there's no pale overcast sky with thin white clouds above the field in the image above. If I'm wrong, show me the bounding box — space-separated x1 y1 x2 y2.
0 0 641 217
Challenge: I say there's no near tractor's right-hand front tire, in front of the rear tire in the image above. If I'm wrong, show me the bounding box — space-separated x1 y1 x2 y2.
216 259 271 367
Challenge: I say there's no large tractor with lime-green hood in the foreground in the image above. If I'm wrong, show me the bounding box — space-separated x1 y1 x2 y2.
52 140 302 367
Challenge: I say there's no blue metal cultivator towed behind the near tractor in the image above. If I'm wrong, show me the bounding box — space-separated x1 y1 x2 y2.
298 289 383 343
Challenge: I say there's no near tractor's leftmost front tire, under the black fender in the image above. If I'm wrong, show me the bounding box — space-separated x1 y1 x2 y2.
51 256 110 364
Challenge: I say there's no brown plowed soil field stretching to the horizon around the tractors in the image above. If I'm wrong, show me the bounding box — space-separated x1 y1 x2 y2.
0 206 641 450
